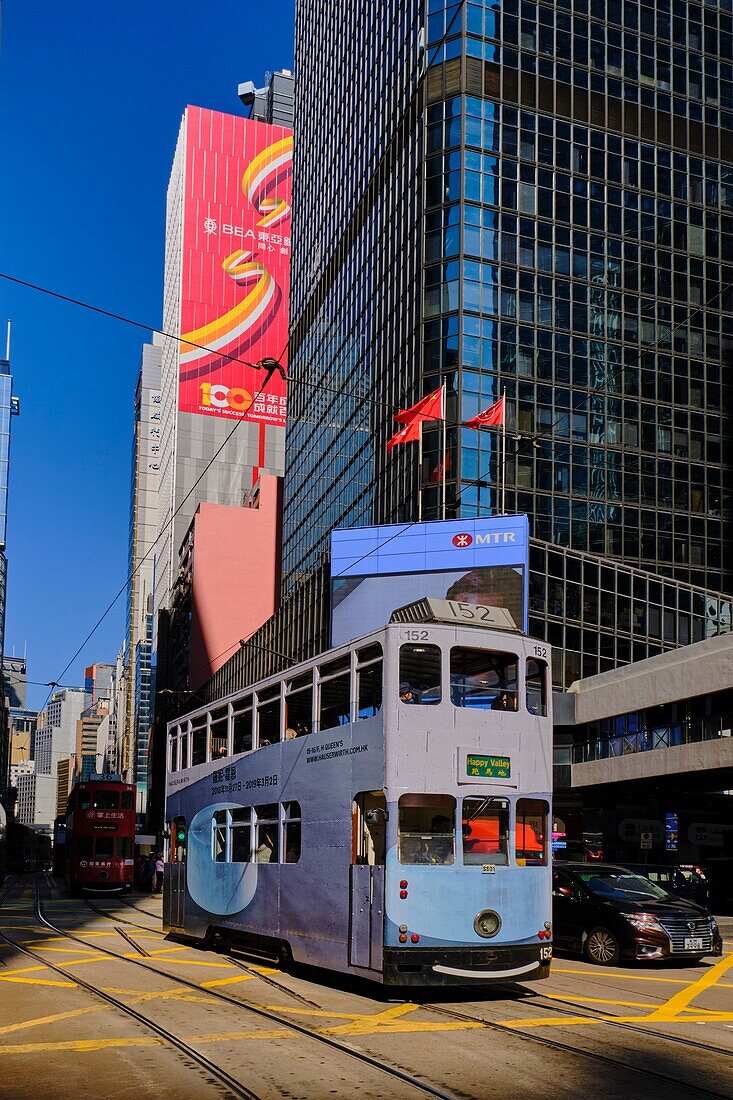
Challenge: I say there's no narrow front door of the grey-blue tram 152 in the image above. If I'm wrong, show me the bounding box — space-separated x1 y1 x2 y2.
349 791 386 970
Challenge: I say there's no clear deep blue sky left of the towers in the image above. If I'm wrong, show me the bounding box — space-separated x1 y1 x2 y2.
0 0 293 706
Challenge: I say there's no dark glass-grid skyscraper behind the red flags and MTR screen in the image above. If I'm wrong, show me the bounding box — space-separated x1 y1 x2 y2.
201 0 733 704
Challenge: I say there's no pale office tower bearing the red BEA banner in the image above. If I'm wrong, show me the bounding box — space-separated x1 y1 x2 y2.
154 107 292 630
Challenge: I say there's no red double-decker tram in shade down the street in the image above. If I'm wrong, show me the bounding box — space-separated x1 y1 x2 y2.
65 779 135 893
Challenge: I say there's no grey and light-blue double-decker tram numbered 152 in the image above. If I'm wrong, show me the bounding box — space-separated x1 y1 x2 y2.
164 598 553 986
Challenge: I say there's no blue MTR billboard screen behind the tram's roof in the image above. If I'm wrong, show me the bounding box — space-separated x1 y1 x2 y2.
331 516 529 646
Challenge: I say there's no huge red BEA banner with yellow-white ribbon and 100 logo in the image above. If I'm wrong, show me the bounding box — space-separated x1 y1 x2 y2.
178 107 293 426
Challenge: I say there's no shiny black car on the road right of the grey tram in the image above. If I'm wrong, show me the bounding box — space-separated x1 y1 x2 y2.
553 864 723 966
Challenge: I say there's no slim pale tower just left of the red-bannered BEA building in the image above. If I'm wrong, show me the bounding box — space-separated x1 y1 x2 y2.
122 333 163 805
